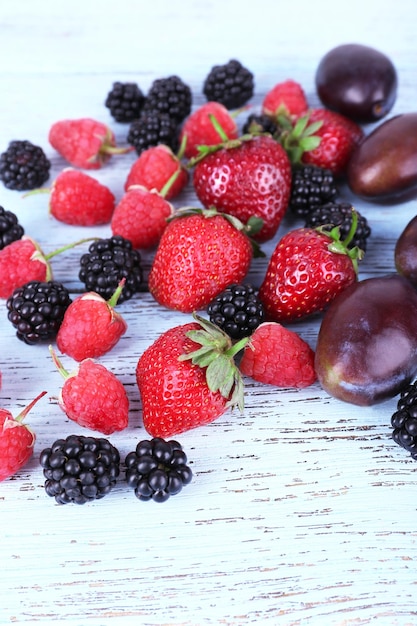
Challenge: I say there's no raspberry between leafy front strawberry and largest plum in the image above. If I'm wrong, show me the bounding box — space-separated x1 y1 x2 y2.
239 322 317 388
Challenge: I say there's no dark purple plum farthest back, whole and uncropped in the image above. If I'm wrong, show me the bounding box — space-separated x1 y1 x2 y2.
315 43 398 124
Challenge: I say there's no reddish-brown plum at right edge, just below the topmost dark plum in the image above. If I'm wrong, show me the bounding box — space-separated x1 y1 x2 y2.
346 112 417 203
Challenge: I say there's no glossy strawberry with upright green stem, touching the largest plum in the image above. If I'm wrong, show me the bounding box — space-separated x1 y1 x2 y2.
259 211 362 322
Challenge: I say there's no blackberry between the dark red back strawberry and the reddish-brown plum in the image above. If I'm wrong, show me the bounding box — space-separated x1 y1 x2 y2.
288 165 338 217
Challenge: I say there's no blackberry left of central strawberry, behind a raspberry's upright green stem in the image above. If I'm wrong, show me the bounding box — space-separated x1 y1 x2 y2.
79 235 143 304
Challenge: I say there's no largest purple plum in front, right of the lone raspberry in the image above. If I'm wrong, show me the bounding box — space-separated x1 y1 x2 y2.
315 273 417 406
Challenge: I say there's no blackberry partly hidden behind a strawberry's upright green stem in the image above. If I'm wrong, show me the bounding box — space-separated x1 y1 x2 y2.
305 202 371 252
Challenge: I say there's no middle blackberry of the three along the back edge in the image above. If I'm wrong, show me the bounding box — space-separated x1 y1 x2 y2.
144 76 192 125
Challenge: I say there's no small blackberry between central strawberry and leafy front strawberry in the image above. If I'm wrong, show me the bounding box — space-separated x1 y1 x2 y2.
207 283 265 339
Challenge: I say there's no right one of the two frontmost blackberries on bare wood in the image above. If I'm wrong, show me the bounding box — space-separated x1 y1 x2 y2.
125 437 192 502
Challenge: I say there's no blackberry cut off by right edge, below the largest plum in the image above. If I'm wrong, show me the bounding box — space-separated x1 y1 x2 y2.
391 381 417 459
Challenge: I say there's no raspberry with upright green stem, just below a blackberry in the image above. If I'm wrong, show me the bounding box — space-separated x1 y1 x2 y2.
56 279 127 361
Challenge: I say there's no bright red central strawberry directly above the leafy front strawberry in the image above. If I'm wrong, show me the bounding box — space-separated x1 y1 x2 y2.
148 209 253 313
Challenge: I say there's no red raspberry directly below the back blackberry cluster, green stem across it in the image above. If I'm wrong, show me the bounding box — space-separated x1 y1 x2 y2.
124 144 189 200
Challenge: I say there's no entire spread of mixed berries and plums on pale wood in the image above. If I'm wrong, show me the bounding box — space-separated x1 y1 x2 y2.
0 44 417 504
